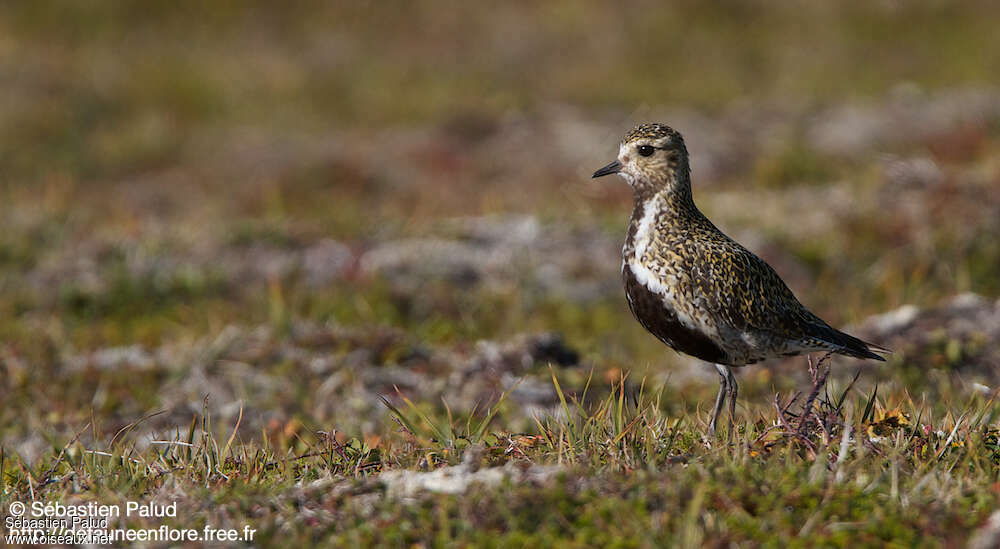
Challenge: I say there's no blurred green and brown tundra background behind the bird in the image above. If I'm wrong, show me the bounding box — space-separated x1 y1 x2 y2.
0 0 1000 456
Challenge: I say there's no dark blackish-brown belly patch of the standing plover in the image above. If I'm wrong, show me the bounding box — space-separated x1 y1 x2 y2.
622 267 729 364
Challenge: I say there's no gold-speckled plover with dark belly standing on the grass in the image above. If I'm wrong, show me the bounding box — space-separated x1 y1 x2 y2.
593 123 890 437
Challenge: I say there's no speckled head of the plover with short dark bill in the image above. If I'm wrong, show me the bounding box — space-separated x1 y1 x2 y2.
594 124 690 194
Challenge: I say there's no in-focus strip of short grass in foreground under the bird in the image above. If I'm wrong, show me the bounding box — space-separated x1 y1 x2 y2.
2 373 1000 547
